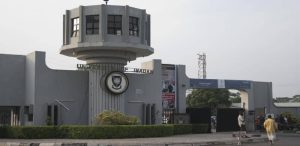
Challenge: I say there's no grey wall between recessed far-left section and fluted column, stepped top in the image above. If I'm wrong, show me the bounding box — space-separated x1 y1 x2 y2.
31 52 89 125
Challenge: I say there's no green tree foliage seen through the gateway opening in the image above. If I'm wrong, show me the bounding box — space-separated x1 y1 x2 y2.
186 89 231 108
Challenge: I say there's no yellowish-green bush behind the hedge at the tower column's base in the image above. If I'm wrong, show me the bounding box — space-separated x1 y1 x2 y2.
96 111 139 125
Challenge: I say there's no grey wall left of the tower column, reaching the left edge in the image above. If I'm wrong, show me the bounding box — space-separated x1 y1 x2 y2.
0 52 88 125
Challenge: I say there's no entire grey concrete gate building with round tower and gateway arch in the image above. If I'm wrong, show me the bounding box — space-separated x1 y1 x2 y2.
0 5 296 130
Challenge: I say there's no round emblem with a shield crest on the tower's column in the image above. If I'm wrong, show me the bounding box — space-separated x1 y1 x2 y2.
105 71 129 94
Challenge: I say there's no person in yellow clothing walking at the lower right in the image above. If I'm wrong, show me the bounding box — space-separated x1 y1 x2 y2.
264 115 277 145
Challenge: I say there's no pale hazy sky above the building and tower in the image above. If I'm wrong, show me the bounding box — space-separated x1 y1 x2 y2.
0 0 300 97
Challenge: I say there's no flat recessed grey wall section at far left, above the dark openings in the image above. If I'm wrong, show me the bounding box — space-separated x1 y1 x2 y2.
0 54 25 106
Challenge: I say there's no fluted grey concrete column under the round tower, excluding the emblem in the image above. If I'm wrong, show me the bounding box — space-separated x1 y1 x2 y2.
89 64 125 125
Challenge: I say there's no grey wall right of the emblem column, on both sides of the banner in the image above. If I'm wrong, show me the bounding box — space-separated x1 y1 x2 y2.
125 60 189 124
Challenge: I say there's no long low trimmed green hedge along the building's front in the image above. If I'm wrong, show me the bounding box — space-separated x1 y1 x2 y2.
0 124 208 139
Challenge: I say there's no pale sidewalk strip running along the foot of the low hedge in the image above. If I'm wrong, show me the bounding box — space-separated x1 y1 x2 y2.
0 132 267 146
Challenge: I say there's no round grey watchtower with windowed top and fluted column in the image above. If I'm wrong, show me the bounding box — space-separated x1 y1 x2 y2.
60 4 154 124
